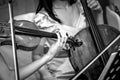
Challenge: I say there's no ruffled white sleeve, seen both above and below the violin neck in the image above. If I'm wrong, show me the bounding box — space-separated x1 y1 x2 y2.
34 12 61 47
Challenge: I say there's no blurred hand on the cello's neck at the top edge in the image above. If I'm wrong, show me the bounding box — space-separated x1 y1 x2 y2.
87 0 103 12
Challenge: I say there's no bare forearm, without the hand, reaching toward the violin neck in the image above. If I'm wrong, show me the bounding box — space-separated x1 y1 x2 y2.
20 54 52 80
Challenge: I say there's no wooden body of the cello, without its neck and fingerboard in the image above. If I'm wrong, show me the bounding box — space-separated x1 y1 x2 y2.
70 25 120 80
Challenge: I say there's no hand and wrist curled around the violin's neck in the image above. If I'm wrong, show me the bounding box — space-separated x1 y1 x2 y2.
47 32 67 59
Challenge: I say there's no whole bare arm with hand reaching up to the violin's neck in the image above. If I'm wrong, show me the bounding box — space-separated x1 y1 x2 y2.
20 31 67 80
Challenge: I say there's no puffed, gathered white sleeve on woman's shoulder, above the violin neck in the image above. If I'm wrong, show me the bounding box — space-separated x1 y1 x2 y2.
34 11 59 32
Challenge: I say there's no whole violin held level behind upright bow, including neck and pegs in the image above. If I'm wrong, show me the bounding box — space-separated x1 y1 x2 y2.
0 20 82 51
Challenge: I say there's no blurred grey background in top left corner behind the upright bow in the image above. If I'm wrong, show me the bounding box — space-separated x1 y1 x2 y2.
0 0 38 22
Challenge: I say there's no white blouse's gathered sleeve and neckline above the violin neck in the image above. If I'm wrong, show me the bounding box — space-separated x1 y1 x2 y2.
34 3 86 36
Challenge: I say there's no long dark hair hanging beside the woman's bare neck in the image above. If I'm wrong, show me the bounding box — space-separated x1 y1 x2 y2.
36 0 77 23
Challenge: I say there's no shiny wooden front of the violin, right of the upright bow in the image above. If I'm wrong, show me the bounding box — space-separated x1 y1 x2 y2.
14 20 40 47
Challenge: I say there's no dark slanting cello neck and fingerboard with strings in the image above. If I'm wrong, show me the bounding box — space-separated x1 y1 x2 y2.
81 1 108 66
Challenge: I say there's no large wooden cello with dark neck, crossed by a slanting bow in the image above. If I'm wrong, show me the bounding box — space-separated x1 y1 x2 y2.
70 0 120 80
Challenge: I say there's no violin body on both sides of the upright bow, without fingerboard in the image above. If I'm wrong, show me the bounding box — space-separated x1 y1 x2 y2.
0 20 40 51
